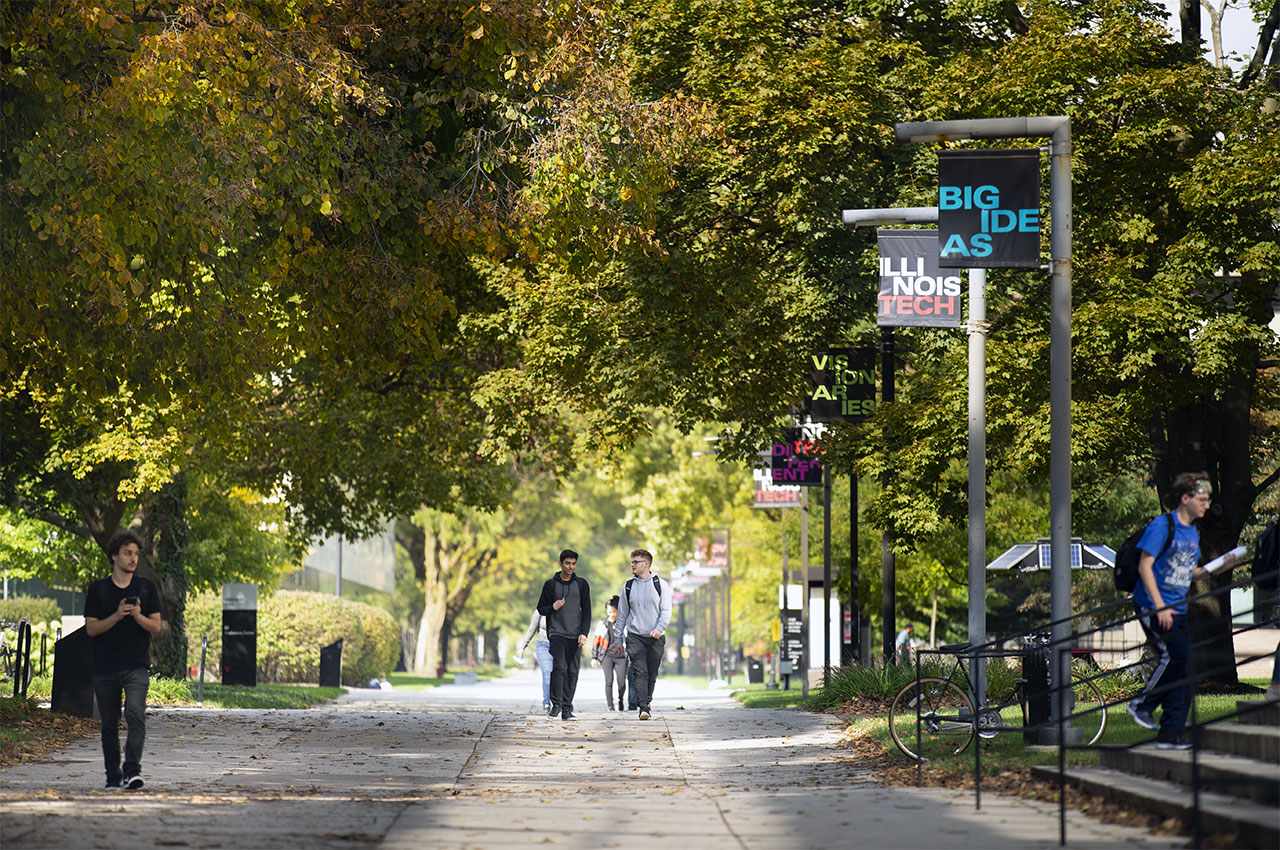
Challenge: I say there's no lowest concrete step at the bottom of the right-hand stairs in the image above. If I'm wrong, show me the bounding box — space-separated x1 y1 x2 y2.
1032 767 1280 850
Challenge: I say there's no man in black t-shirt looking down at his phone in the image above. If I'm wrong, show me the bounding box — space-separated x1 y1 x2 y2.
84 531 160 791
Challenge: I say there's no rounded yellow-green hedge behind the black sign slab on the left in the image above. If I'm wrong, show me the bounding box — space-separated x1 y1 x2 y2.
187 590 399 686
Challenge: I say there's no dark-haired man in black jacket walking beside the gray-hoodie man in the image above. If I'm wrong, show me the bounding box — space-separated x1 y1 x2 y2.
538 549 591 721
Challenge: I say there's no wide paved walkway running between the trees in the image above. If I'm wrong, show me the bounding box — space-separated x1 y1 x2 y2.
0 670 1183 850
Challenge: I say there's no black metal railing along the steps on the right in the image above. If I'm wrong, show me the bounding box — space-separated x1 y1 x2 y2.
915 561 1280 847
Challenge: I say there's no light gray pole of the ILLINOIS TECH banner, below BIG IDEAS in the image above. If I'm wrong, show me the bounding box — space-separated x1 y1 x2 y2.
969 269 987 694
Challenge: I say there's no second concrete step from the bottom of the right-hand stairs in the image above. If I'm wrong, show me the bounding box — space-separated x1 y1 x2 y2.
1098 744 1280 806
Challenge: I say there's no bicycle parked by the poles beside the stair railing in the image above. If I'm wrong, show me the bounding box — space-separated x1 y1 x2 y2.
888 635 1107 762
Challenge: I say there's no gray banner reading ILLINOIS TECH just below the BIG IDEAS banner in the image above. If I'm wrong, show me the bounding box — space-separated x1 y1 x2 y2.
876 230 964 328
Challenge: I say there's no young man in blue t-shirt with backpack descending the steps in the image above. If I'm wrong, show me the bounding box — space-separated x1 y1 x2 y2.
1128 472 1235 750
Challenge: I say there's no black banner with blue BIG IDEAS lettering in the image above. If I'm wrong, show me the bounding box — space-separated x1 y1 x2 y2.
938 148 1041 269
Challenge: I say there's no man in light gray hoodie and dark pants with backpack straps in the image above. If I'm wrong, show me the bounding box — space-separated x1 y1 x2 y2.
614 549 671 721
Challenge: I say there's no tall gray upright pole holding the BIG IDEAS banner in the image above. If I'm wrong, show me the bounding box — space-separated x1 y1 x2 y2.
1048 119 1071 717
